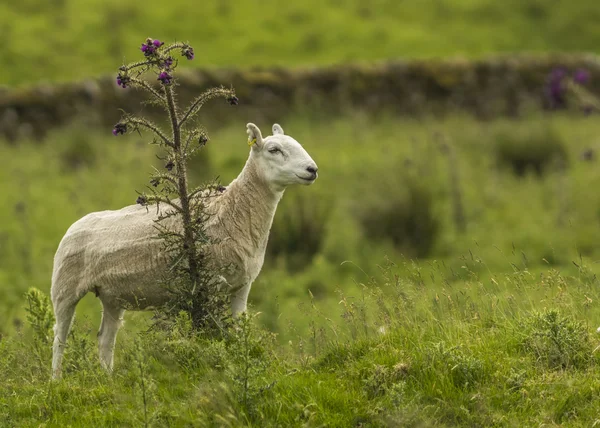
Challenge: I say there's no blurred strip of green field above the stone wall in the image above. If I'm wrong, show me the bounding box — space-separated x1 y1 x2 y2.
0 0 600 86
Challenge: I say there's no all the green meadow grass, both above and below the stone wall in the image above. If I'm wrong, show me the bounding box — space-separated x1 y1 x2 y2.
0 0 600 422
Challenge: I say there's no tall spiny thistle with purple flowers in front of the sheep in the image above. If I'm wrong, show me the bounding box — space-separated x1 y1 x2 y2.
112 38 238 328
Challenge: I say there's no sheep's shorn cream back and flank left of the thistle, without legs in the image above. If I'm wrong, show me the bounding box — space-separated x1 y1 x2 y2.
53 205 180 308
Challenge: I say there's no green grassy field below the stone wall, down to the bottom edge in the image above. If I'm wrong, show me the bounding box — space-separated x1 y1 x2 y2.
0 112 600 427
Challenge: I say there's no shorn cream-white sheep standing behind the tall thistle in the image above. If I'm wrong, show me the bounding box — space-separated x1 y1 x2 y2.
51 123 317 378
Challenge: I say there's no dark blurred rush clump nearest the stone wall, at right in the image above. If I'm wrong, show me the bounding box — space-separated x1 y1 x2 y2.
493 121 568 176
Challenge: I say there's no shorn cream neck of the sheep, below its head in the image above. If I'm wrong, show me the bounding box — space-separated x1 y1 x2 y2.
221 159 283 256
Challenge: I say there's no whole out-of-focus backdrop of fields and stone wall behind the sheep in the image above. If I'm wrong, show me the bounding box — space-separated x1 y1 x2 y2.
0 0 600 337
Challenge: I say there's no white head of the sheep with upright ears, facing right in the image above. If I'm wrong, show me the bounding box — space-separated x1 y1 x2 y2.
246 123 317 189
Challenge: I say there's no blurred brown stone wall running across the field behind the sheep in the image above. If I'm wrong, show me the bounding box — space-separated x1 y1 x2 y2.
0 54 600 141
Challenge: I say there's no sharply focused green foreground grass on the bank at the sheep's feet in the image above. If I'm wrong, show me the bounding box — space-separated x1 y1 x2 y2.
0 265 600 427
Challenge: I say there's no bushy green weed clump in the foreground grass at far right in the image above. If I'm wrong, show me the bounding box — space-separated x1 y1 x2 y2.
520 309 593 370
